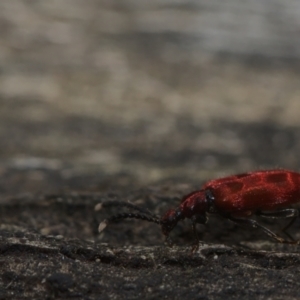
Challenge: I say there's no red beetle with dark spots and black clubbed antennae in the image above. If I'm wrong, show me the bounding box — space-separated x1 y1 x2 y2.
96 170 300 244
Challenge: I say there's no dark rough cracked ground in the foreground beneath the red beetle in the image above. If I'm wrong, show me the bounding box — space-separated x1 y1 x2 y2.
0 190 300 299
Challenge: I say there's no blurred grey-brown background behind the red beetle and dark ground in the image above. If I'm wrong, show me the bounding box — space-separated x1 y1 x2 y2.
0 0 300 195
